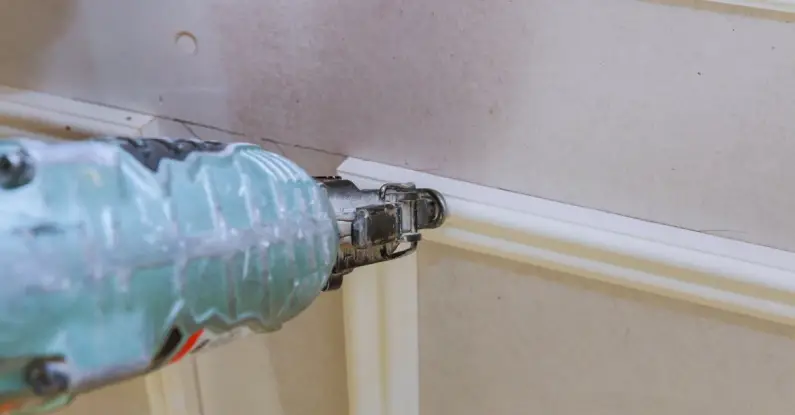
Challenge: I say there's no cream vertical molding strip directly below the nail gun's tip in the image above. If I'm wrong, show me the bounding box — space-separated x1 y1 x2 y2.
342 255 419 415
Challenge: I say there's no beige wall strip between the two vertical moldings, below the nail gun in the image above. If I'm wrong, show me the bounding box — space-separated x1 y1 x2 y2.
197 292 348 415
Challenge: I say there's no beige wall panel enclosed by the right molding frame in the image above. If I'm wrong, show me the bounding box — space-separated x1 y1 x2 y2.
419 244 795 415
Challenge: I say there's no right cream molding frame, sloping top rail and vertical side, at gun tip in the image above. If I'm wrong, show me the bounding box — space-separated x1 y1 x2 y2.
338 158 795 415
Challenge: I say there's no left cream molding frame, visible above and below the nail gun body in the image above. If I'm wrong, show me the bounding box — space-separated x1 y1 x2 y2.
0 86 201 415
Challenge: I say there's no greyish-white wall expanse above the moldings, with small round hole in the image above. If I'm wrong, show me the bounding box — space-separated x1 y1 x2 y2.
0 0 795 250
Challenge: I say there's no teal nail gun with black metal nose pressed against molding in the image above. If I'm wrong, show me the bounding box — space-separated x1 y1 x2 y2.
0 138 446 413
